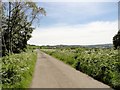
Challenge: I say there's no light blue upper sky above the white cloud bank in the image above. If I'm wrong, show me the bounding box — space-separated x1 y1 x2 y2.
38 2 118 27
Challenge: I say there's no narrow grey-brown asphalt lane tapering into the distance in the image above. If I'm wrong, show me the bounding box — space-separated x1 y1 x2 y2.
31 50 110 88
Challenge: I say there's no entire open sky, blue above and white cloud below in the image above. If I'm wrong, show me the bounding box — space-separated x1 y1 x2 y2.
28 0 118 45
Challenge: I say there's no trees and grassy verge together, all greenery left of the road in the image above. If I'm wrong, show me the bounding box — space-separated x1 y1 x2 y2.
0 0 46 88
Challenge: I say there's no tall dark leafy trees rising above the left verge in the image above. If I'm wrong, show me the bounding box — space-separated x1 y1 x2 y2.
1 1 46 56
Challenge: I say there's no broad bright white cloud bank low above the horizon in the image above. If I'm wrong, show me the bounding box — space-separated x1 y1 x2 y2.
28 21 118 45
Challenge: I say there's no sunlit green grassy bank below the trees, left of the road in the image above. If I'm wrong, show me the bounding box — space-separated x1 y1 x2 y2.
0 51 37 88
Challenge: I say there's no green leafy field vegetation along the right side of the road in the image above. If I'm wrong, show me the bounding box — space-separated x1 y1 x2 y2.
41 48 120 89
